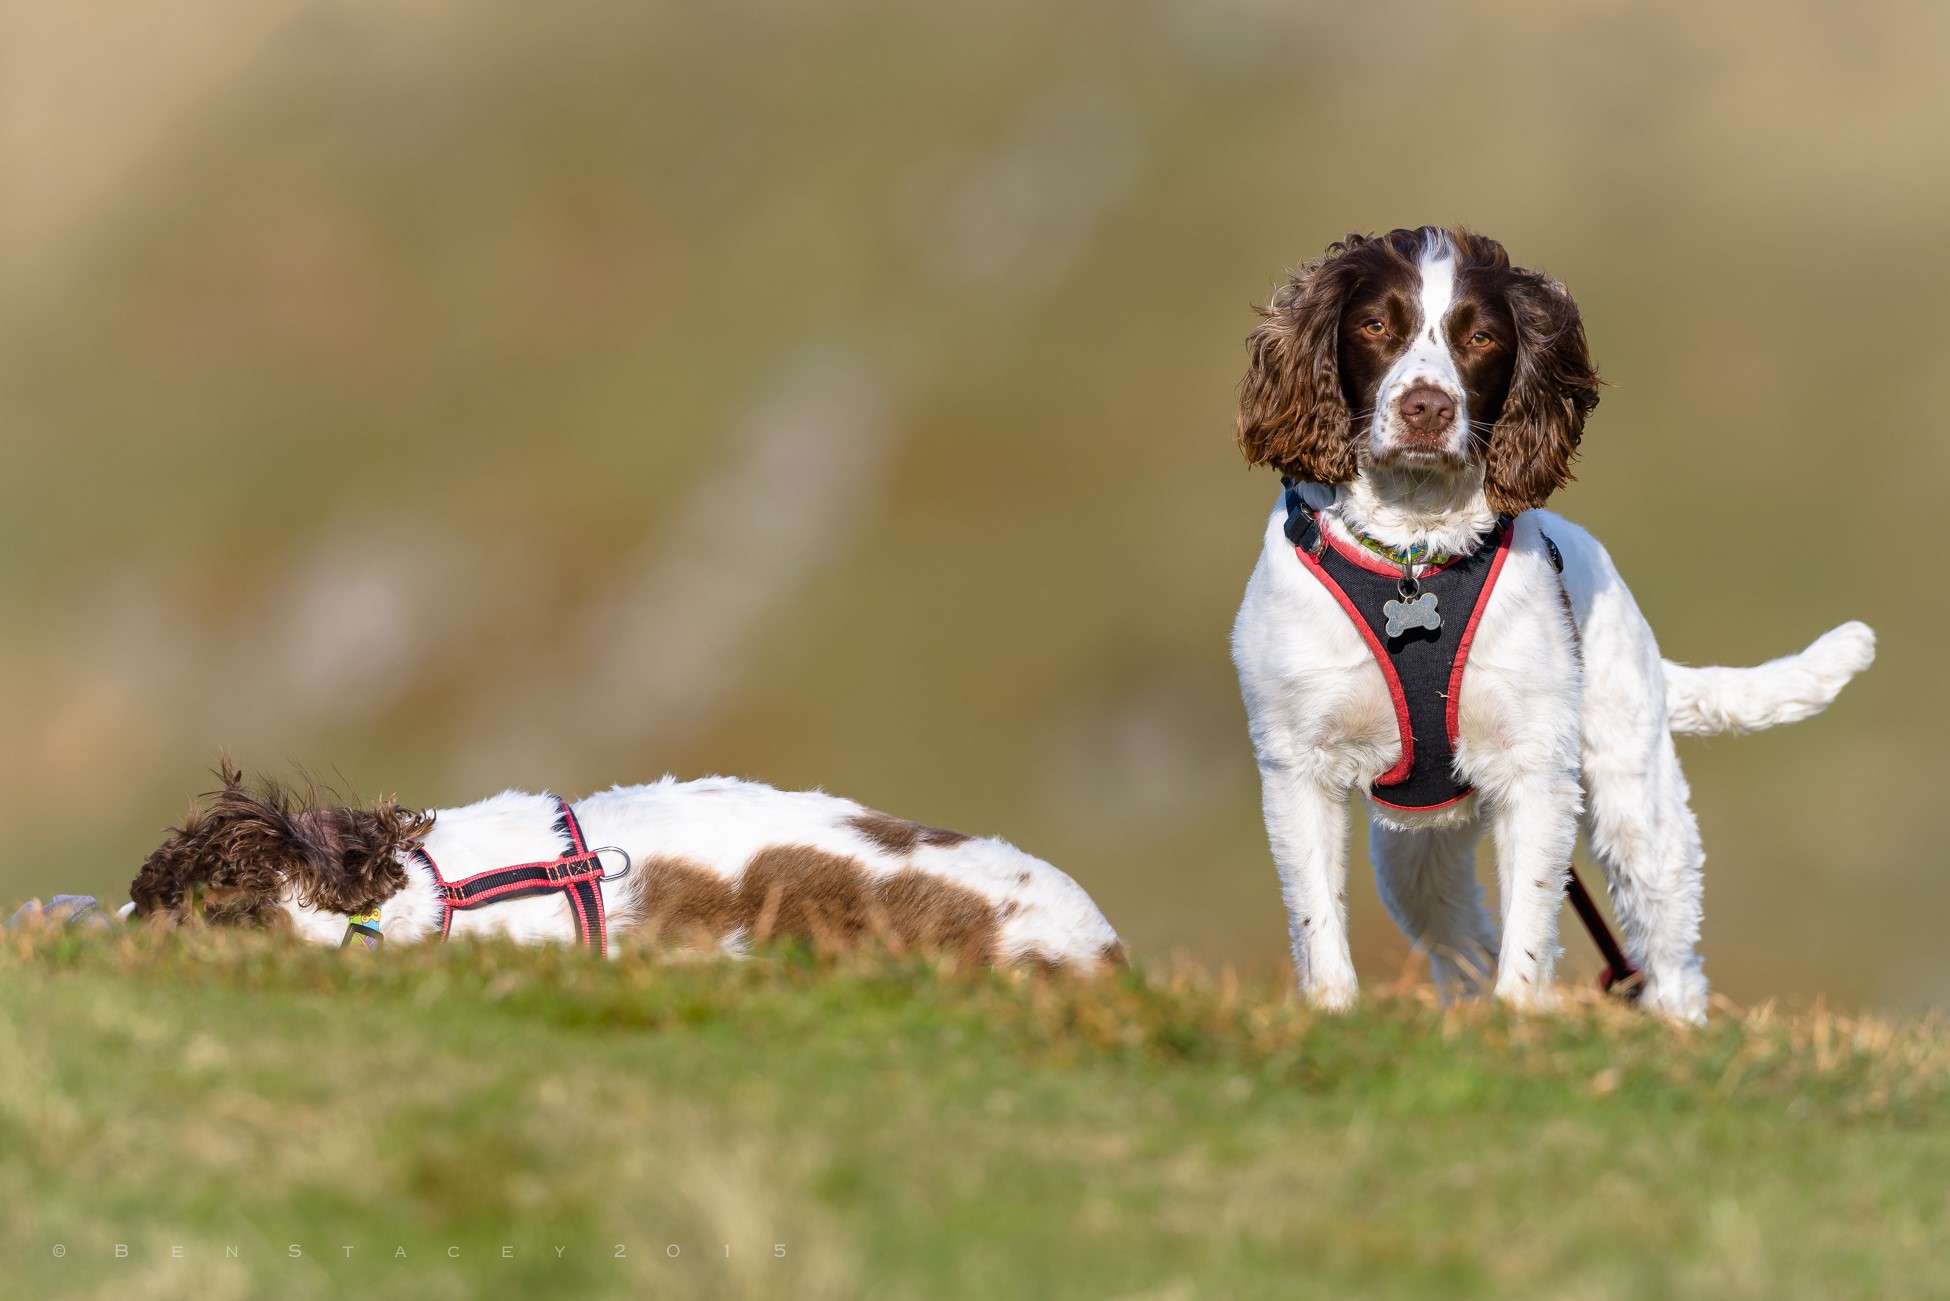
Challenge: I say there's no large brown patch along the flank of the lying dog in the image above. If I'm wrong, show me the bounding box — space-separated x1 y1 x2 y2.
638 845 998 964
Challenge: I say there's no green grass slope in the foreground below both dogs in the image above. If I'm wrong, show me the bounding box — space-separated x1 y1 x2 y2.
0 932 1950 1301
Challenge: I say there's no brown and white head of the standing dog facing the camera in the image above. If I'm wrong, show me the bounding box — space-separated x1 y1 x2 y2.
1238 226 1599 513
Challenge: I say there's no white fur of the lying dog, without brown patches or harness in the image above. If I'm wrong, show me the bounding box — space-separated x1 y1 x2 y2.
285 776 1117 966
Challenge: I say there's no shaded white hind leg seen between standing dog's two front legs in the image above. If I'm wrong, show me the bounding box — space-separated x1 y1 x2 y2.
1367 817 1498 1003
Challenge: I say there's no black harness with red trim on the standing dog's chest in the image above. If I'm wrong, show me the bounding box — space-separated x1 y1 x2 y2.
1287 488 1511 809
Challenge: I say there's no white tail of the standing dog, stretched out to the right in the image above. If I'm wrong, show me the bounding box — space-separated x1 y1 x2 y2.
1665 622 1876 735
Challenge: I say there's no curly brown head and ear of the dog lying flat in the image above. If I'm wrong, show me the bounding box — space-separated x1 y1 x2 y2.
129 759 433 926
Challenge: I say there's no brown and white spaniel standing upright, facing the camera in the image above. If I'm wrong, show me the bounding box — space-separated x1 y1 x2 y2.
1232 226 1874 1020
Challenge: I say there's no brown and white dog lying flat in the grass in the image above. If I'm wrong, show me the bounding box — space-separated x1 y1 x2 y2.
129 763 1123 967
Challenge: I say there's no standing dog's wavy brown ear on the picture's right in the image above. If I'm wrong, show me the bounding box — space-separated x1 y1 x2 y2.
1484 271 1599 515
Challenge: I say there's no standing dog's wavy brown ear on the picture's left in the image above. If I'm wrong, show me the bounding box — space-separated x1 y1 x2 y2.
1238 234 1367 484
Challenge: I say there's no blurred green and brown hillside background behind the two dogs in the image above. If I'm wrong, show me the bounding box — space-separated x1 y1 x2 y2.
0 0 1950 1006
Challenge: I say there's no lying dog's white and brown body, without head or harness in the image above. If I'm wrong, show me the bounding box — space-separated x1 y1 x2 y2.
386 776 1117 964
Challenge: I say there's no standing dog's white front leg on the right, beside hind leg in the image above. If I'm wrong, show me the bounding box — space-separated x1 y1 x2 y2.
1490 770 1578 1008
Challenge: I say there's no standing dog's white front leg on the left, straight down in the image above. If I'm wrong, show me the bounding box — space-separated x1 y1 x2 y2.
1260 767 1361 1010
